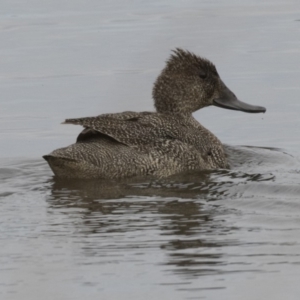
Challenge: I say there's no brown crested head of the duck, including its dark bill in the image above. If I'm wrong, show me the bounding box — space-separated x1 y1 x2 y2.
153 48 266 114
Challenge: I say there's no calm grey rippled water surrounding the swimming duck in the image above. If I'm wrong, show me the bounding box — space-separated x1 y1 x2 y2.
0 0 300 300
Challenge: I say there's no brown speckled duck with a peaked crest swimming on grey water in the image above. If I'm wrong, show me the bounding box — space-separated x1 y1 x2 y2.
43 48 266 179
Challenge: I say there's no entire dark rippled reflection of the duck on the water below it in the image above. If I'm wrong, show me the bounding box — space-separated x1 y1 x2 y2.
48 166 255 279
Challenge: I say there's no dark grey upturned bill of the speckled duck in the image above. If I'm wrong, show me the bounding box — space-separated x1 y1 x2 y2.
213 82 266 113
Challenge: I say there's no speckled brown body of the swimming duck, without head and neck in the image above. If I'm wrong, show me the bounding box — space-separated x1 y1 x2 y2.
44 112 228 179
